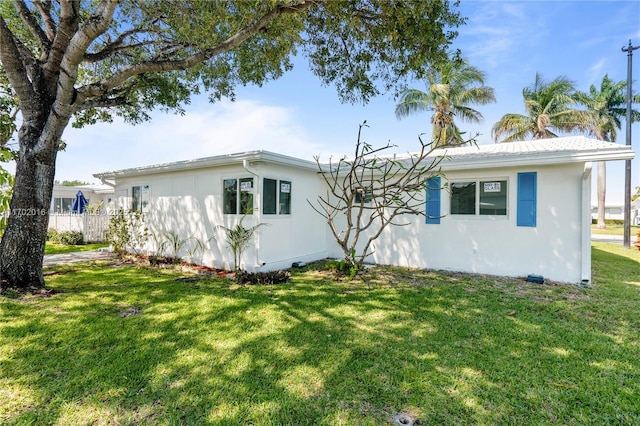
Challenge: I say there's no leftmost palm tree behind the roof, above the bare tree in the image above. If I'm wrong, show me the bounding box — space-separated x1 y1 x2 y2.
396 59 496 146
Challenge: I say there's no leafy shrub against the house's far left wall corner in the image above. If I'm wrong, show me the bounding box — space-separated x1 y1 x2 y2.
107 209 150 256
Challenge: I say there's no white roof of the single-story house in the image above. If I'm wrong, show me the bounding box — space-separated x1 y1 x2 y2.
93 136 634 181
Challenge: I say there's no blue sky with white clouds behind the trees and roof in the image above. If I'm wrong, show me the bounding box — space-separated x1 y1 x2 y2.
51 0 640 203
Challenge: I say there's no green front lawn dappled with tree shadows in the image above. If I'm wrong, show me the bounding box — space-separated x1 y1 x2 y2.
0 243 640 425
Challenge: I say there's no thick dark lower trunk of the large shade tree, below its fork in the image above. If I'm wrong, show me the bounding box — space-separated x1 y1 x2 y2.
0 132 57 291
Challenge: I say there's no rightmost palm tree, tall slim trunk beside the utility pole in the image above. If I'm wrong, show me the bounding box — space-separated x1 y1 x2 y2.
575 75 640 229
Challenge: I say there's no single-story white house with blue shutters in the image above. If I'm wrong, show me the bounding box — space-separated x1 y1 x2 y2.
94 137 634 283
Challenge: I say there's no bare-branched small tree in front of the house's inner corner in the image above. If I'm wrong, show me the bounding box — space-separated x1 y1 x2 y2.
309 123 452 270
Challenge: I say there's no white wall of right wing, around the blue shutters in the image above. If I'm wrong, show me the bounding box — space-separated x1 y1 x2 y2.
328 163 591 283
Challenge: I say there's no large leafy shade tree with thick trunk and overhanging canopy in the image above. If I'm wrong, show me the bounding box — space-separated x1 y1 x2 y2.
0 0 464 290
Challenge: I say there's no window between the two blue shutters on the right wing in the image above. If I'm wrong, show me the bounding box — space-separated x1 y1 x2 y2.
451 180 507 216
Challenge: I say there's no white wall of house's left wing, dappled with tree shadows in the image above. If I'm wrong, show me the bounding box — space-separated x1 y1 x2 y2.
116 163 327 271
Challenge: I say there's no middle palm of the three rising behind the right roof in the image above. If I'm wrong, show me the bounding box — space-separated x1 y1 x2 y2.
491 73 587 142
